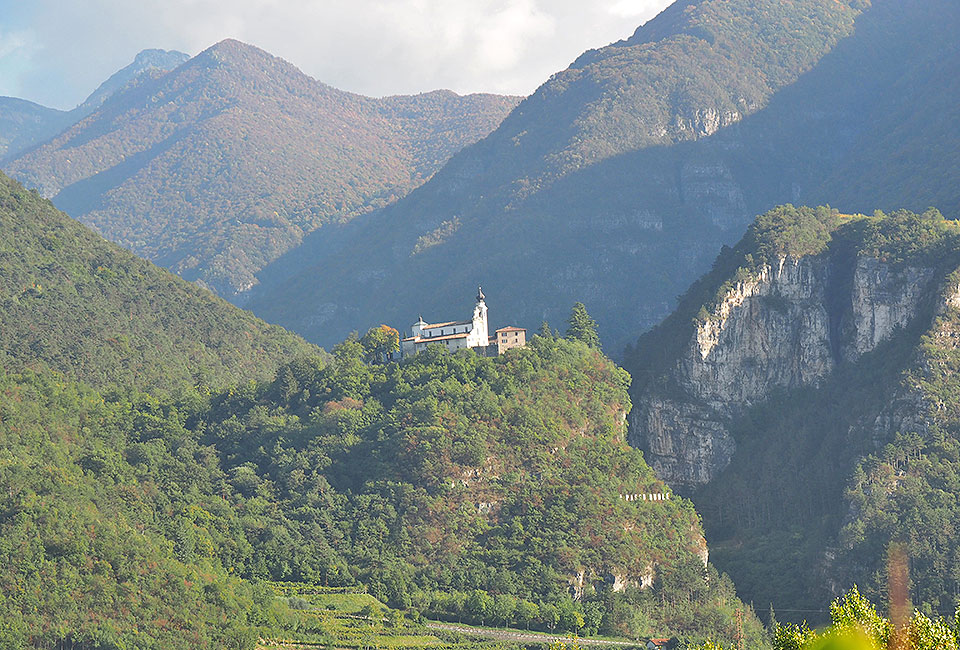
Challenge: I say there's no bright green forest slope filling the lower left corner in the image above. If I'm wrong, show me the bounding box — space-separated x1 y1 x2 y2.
0 372 290 650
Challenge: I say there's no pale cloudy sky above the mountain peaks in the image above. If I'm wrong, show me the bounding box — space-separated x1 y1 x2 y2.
0 0 670 109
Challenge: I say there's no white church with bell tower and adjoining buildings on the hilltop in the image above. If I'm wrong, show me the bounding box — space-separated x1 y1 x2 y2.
400 288 527 357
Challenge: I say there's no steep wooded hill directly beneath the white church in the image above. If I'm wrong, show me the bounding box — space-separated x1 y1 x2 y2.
204 336 760 641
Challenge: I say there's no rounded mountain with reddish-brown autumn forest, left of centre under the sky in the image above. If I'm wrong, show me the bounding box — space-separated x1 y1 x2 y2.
5 40 517 298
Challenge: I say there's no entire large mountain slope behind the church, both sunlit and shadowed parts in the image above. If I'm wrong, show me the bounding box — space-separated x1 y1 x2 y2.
248 0 960 354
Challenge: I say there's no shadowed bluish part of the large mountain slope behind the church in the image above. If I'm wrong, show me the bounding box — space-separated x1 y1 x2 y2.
249 0 960 354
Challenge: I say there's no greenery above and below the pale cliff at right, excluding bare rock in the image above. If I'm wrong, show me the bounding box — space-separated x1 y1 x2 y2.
626 206 960 619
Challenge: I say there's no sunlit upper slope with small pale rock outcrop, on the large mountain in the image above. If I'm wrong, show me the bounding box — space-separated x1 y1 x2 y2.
550 0 869 182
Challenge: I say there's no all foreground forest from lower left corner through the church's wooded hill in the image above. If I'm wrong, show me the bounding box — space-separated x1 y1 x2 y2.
0 337 765 650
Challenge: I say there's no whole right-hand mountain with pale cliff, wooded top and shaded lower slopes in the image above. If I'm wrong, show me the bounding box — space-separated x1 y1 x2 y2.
627 206 960 617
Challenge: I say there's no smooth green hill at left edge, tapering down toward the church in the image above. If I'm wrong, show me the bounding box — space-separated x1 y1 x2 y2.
0 174 317 390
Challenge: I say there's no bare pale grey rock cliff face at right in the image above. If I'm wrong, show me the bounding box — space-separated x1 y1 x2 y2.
630 254 934 487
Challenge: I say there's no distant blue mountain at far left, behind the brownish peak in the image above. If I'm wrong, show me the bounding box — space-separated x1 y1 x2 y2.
0 50 190 160
